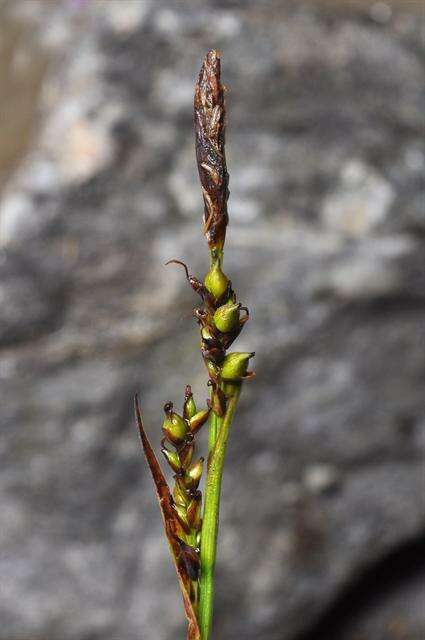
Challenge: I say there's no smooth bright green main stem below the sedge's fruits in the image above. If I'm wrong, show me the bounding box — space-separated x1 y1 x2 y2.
198 384 241 640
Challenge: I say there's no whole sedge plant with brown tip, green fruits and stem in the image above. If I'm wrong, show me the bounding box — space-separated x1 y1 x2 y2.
135 50 254 640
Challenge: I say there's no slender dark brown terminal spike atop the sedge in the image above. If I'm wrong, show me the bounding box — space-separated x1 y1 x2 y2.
194 49 229 251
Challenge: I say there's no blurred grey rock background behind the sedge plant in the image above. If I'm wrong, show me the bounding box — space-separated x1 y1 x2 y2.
0 0 425 640
